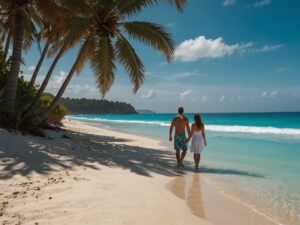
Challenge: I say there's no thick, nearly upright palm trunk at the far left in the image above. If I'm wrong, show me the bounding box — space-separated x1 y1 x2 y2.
4 6 25 112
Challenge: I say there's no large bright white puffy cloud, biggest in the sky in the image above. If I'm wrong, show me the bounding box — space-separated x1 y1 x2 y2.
175 36 253 62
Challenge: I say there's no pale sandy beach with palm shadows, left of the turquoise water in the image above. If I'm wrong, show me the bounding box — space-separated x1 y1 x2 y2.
0 120 274 225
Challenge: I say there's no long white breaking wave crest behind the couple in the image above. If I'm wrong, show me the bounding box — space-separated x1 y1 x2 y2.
68 116 300 138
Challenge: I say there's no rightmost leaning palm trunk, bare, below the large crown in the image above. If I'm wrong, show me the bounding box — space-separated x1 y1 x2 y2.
31 46 83 127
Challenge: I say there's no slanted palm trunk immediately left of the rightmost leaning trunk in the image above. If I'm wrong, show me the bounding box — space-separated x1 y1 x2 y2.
23 44 66 119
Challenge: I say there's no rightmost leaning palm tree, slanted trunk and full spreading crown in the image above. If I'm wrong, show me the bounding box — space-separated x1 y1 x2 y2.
30 0 185 125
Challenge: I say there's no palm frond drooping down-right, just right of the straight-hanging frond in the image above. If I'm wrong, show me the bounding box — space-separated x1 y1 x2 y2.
115 34 145 93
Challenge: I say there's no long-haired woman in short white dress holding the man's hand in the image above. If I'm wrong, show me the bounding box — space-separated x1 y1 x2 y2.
187 114 207 170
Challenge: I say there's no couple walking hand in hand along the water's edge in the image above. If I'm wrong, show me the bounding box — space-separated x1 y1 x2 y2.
169 107 207 169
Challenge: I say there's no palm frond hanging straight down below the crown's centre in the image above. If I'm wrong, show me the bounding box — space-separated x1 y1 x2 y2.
91 38 116 97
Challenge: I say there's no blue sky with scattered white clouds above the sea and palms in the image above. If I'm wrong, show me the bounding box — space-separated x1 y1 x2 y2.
22 0 300 113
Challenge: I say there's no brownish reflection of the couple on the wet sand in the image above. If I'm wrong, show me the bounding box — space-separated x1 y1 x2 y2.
170 173 205 218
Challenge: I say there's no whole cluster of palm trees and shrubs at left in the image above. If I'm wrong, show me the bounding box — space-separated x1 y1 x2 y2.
0 0 186 133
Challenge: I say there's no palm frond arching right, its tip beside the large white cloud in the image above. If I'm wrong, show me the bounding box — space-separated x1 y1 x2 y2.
120 22 175 62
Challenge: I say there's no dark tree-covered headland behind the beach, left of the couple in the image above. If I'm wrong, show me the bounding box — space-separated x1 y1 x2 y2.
61 98 137 114
